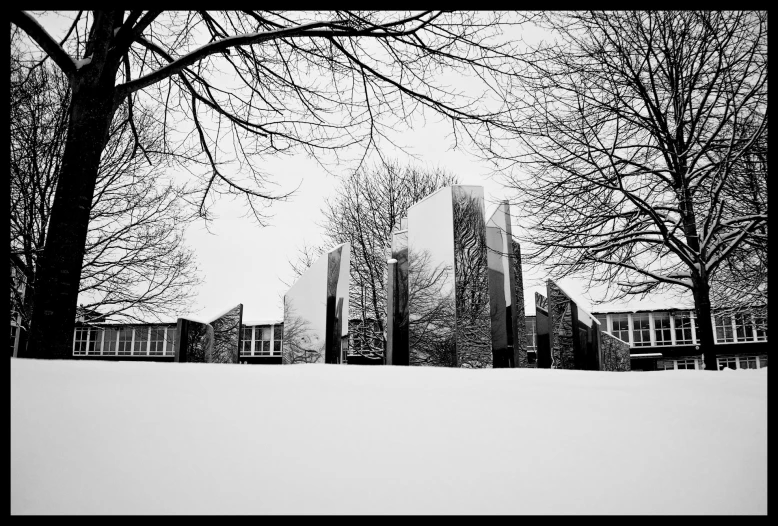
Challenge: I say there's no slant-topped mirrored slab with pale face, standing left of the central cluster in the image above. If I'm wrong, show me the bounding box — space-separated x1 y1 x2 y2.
282 243 350 364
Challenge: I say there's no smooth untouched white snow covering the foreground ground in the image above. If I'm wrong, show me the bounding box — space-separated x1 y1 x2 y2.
11 358 767 515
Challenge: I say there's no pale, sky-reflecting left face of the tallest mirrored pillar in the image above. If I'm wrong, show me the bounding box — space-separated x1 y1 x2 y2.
408 187 458 367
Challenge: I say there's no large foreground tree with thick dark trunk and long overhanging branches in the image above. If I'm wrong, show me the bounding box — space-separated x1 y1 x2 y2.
11 11 528 358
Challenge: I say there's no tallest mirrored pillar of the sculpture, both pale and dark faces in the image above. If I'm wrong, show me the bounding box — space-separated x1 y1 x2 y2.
408 186 493 367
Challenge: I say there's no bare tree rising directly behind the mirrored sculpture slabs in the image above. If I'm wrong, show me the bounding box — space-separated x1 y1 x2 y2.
290 160 457 355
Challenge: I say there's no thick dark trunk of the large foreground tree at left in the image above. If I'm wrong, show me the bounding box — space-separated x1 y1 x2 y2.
20 80 114 358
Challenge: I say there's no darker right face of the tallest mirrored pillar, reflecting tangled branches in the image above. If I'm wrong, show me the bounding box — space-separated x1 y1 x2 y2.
452 186 493 368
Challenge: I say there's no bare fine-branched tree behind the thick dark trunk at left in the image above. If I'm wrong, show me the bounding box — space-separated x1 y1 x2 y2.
10 43 198 352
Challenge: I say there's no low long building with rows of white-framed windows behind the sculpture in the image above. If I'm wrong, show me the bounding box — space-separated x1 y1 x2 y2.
11 302 768 371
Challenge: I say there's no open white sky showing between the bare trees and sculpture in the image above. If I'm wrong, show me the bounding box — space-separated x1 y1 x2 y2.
25 11 688 321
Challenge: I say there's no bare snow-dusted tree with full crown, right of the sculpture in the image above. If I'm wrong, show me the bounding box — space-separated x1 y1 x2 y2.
498 11 767 369
